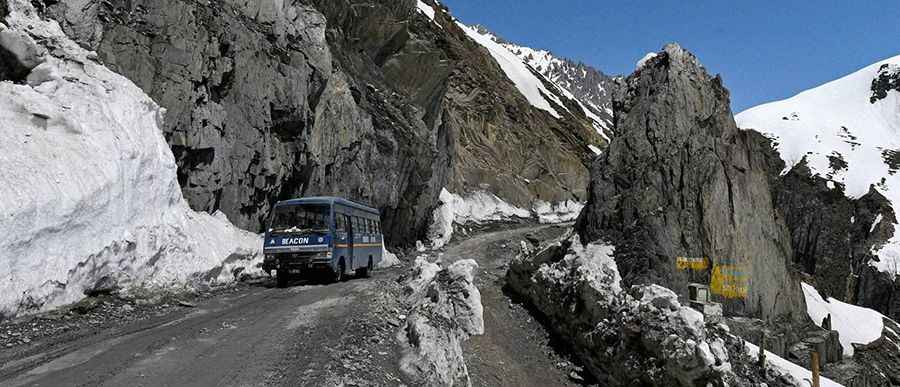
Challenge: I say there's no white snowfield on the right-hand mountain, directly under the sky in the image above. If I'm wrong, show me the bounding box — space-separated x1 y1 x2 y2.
735 56 900 274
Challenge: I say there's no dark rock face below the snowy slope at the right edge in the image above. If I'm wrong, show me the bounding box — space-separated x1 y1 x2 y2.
747 130 896 304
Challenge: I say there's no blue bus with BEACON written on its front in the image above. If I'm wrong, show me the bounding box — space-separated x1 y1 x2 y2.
262 197 384 287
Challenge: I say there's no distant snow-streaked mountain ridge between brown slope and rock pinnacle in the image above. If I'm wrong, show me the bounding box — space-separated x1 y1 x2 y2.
460 24 615 146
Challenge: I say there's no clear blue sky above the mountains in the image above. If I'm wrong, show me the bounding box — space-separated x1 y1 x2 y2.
442 0 900 112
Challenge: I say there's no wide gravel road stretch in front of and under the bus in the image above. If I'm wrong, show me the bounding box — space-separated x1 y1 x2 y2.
0 271 401 386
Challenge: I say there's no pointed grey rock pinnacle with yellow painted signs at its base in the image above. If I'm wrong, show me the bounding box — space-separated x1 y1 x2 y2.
577 45 803 319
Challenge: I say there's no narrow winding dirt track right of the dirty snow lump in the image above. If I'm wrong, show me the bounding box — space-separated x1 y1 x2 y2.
443 225 584 387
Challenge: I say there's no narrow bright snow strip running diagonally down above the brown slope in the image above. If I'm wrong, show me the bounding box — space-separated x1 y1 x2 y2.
457 22 565 118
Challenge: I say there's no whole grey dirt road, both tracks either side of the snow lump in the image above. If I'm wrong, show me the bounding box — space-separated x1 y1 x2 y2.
0 226 584 386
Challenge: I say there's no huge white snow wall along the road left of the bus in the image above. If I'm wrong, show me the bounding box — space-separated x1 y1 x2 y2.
0 0 261 315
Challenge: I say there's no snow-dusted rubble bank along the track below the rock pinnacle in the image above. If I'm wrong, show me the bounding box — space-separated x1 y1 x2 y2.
507 232 798 386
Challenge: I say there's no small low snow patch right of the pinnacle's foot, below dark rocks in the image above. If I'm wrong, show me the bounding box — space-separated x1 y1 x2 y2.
801 283 884 357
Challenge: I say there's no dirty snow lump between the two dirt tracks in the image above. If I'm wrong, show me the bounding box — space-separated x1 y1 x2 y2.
397 256 484 386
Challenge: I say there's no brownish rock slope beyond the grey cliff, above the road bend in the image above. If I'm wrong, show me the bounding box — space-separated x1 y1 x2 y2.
439 21 603 208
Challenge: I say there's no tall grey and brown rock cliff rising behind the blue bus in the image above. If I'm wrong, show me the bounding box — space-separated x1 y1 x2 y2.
36 0 599 244
